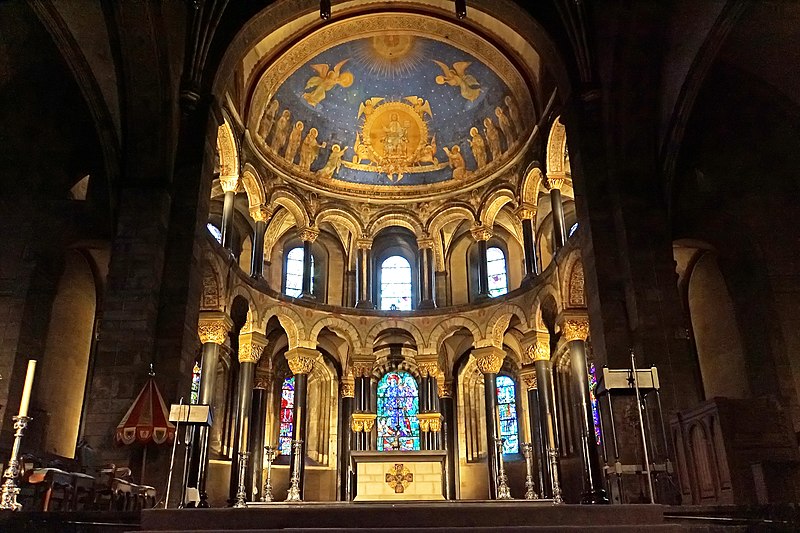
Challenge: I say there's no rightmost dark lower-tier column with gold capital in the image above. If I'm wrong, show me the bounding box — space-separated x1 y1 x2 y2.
560 314 609 503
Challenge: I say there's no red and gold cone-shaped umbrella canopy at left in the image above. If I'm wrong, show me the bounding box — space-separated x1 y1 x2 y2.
115 378 175 444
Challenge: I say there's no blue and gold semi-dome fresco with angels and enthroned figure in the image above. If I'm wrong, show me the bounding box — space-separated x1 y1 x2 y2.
250 14 534 202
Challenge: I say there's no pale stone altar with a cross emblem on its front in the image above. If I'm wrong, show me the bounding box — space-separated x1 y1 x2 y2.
350 450 446 502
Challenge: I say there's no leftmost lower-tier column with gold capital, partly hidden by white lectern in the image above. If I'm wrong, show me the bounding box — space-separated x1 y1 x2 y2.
193 311 233 507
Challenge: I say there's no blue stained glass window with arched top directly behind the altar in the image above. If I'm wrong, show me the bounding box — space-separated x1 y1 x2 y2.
377 371 419 451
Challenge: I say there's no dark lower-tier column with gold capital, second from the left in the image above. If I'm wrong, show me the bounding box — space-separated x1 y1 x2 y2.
234 331 267 507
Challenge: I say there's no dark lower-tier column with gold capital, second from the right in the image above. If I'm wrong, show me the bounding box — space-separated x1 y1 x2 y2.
528 332 556 498
